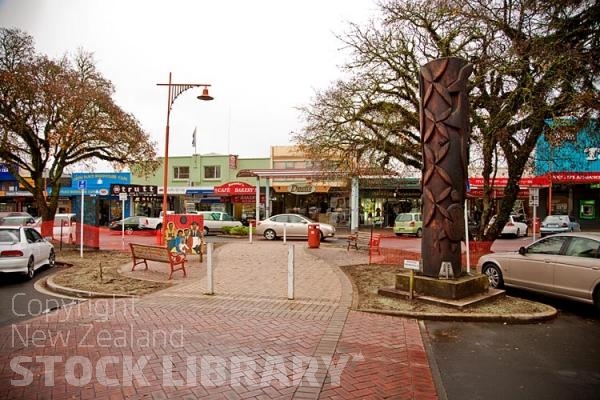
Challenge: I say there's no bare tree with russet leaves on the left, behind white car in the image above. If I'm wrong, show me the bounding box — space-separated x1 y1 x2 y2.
0 28 157 228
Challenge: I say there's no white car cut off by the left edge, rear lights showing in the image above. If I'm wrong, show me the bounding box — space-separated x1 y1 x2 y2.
0 225 55 279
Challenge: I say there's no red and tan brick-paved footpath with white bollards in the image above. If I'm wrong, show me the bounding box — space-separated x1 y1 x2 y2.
0 241 438 399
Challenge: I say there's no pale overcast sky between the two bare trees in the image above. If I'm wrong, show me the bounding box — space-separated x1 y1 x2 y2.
0 0 377 161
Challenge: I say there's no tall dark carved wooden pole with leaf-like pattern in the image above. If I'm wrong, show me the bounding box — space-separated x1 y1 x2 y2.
419 57 473 278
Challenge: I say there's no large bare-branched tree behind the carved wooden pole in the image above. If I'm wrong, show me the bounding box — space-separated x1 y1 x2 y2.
294 0 600 239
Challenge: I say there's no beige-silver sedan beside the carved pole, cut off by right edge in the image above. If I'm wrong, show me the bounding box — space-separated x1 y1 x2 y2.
477 232 600 309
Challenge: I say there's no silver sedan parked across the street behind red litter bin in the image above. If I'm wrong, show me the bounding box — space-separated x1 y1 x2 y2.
256 214 335 241
